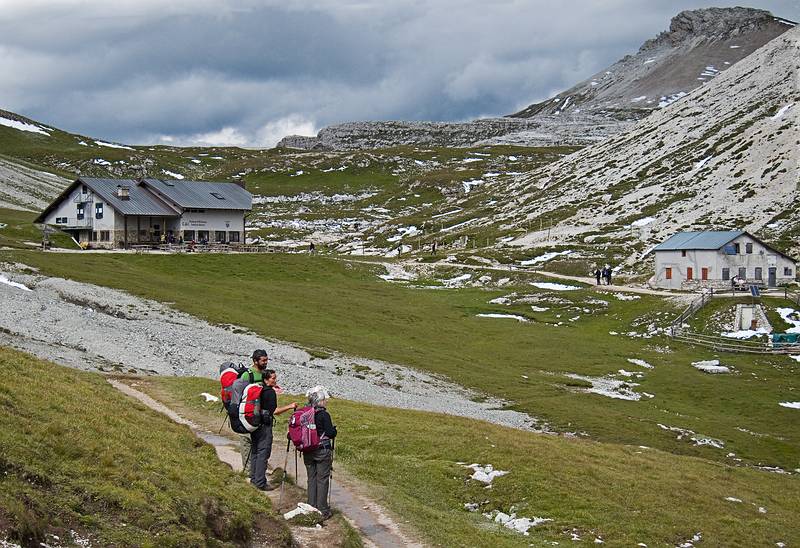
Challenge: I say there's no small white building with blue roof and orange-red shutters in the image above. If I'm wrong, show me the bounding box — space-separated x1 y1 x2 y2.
650 230 797 289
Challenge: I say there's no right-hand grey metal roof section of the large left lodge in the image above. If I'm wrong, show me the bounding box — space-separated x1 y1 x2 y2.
144 179 253 211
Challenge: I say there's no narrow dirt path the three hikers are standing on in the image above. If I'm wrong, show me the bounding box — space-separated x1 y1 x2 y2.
108 379 424 548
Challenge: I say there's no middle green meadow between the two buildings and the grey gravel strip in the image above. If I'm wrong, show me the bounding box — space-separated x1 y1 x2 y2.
7 252 800 470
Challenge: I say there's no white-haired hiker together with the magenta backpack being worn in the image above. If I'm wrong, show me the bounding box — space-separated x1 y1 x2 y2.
289 386 336 519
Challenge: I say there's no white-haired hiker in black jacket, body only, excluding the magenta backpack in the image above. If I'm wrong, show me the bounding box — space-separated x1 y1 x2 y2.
303 386 336 519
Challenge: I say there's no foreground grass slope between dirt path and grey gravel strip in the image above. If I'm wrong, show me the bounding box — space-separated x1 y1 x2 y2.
131 377 800 547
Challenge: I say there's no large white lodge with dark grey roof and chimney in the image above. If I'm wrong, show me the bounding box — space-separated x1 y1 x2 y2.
34 177 253 248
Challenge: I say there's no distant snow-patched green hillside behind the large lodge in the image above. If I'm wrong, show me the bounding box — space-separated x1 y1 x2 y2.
0 111 577 261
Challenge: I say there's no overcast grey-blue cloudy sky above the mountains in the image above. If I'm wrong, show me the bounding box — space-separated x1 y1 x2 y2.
0 0 800 146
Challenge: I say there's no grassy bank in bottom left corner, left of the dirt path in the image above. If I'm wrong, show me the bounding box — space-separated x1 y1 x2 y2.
0 348 291 546
